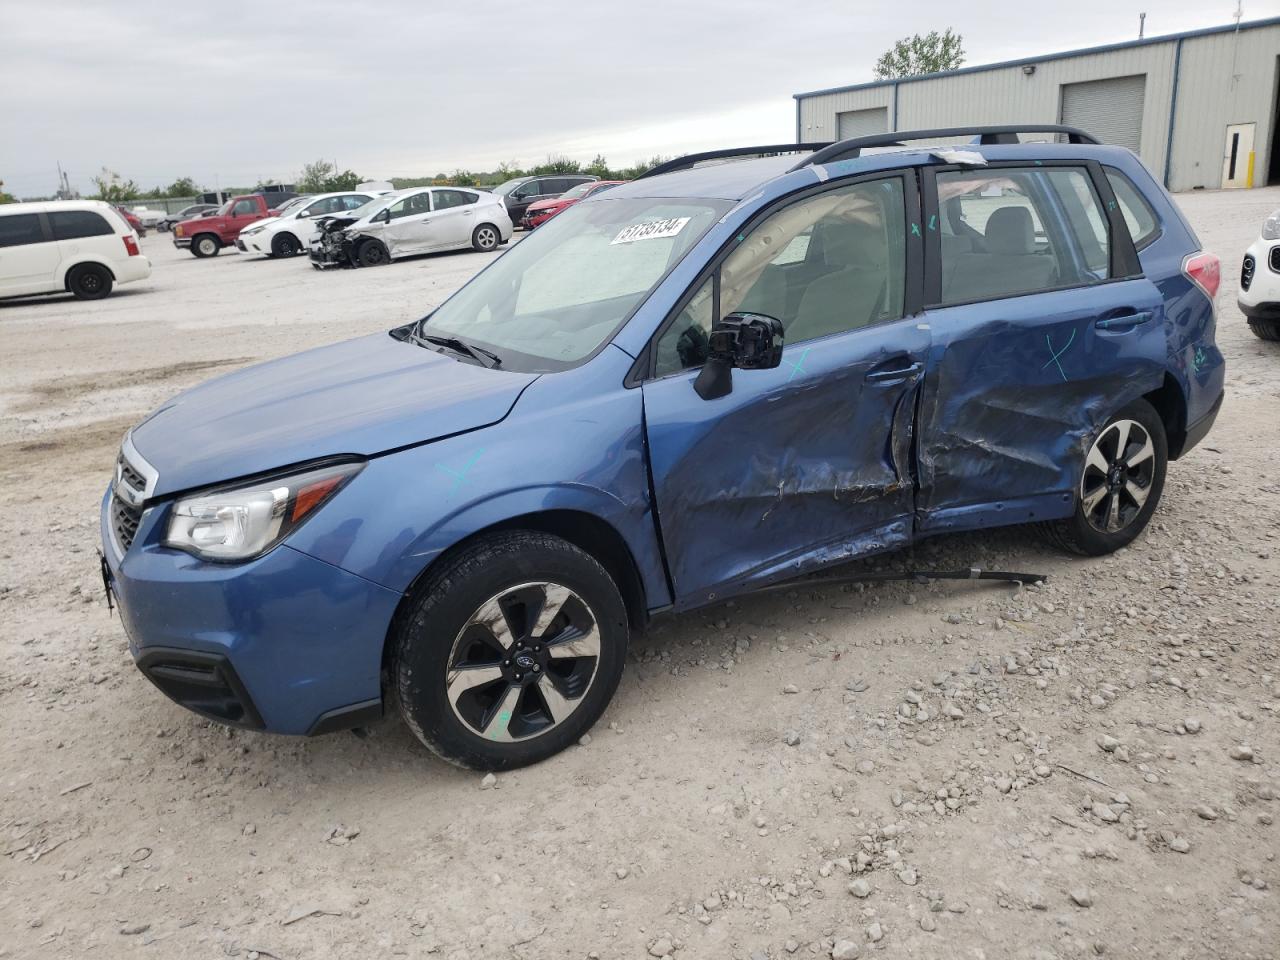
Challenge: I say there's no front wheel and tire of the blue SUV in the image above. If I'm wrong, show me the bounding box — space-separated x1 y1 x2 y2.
392 531 628 771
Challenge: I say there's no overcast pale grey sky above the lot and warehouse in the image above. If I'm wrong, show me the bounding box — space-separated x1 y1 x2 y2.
0 0 1280 196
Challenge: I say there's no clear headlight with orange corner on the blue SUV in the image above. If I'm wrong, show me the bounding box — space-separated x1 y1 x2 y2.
164 463 365 561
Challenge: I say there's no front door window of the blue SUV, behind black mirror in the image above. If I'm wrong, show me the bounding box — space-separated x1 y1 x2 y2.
655 177 906 376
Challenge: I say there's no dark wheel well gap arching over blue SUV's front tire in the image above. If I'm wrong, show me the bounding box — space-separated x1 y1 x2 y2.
383 509 648 692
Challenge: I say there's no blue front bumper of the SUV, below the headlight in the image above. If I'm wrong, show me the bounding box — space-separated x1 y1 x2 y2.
101 493 401 735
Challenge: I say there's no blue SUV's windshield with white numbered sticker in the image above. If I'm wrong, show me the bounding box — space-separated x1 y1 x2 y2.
421 198 733 372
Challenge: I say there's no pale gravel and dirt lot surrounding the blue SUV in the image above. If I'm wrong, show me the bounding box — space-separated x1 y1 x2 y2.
0 189 1280 960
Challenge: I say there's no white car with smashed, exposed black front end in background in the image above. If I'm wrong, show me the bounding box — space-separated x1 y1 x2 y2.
311 187 512 270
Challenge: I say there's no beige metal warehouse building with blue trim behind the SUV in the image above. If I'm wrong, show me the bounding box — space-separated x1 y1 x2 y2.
795 17 1280 191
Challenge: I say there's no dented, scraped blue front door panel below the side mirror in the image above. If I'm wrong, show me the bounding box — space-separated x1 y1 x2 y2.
644 320 928 602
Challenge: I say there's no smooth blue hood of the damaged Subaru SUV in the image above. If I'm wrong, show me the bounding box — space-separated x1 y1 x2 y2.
132 333 538 494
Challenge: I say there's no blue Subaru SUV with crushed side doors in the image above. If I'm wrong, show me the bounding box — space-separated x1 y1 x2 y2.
101 127 1224 768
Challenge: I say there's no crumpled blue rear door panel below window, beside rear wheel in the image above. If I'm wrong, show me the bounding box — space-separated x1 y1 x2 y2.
916 279 1165 531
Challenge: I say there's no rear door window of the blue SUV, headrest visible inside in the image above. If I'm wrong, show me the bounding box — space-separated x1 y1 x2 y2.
937 168 1111 303
